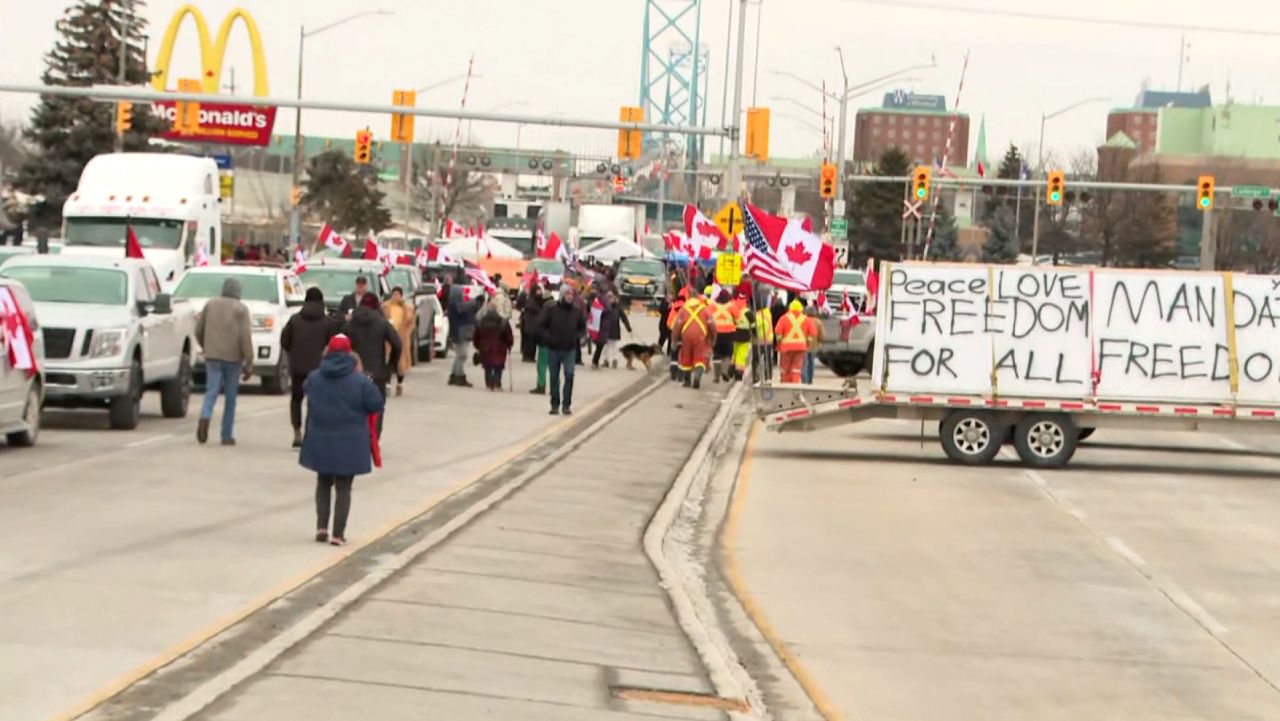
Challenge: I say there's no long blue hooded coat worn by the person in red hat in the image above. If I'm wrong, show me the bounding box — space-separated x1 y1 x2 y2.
298 353 387 475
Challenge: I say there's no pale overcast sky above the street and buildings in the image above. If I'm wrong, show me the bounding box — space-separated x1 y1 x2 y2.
0 0 1280 163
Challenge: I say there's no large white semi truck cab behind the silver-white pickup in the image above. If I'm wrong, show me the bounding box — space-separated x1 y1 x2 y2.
63 152 223 291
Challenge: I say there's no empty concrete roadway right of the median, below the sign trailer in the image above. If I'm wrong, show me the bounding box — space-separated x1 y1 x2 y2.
730 421 1280 721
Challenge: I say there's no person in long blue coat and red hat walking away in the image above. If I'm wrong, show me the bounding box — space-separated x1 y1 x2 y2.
298 334 387 546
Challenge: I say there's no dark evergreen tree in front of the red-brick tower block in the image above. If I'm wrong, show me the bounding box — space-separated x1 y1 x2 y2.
845 147 911 264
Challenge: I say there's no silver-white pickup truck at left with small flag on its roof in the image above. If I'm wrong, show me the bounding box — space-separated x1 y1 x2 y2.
0 255 196 430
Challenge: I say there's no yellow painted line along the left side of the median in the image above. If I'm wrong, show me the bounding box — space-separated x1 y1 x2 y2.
50 392 613 721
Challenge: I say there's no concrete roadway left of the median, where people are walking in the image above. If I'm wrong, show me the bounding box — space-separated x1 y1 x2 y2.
0 319 652 721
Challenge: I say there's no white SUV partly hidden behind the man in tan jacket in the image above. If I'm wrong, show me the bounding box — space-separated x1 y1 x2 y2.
173 263 303 394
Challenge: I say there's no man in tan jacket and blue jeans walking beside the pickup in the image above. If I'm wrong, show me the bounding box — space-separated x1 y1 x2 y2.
196 278 253 446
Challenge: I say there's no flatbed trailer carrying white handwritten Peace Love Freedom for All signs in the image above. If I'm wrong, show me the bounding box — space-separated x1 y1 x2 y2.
755 263 1280 467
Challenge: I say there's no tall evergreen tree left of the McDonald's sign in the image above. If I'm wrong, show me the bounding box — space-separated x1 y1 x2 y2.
15 0 159 225
